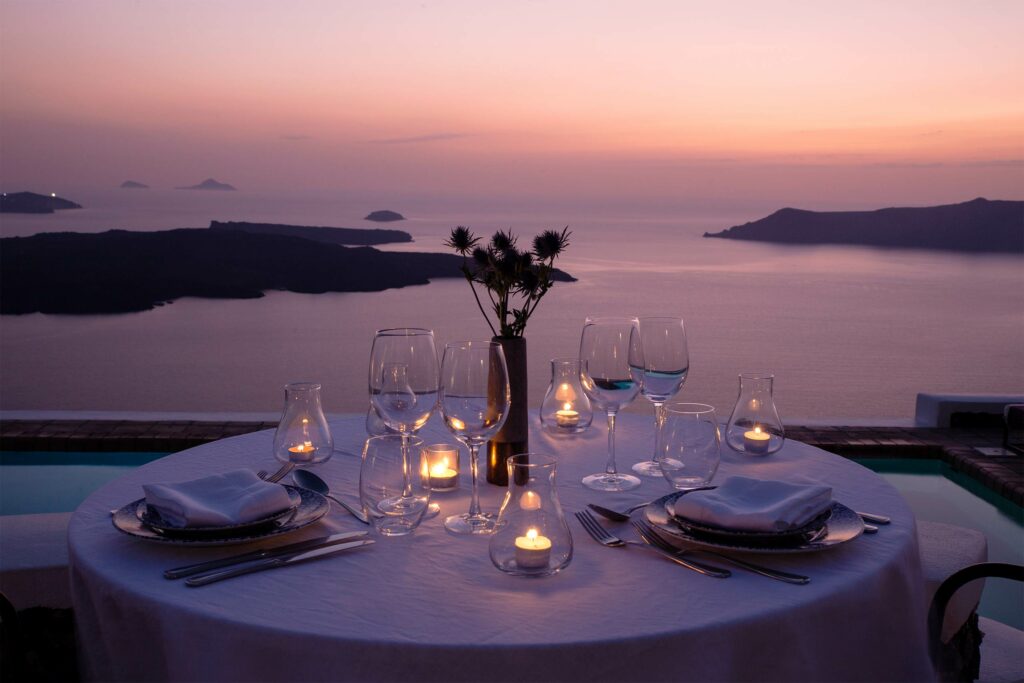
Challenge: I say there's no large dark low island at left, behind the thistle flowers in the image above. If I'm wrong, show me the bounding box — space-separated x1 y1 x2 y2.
0 222 574 314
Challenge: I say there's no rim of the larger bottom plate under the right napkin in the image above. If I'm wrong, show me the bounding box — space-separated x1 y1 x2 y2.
643 492 864 554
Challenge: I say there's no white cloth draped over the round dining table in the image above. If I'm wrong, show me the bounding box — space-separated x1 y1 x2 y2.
69 415 932 681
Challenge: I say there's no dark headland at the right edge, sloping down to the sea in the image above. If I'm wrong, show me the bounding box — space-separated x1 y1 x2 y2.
705 198 1024 254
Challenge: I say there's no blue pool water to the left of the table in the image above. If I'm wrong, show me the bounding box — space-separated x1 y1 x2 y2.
0 451 167 515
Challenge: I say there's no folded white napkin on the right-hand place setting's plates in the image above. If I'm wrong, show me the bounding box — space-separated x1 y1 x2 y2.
675 476 831 532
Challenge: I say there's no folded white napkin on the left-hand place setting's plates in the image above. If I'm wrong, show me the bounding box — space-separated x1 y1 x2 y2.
142 470 292 527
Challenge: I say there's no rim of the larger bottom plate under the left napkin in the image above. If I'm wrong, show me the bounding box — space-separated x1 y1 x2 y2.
111 486 331 546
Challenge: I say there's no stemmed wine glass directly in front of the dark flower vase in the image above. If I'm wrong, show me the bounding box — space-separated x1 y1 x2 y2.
440 341 510 533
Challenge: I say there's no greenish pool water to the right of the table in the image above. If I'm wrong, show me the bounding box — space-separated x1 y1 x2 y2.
857 459 1024 629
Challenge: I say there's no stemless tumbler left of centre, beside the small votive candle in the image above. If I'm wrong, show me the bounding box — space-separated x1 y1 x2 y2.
359 434 430 536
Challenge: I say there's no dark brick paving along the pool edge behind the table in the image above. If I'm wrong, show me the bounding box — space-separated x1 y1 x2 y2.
0 420 1024 506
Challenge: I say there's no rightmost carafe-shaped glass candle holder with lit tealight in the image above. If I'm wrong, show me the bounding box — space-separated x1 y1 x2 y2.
725 373 785 456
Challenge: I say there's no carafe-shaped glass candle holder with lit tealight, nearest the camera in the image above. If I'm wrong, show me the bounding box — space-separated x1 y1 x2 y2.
489 453 572 577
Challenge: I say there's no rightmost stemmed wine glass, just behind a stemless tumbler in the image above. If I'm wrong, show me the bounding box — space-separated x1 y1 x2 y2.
633 317 690 477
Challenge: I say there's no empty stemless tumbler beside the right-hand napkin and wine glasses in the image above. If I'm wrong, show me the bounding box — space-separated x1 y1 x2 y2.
656 403 722 490
